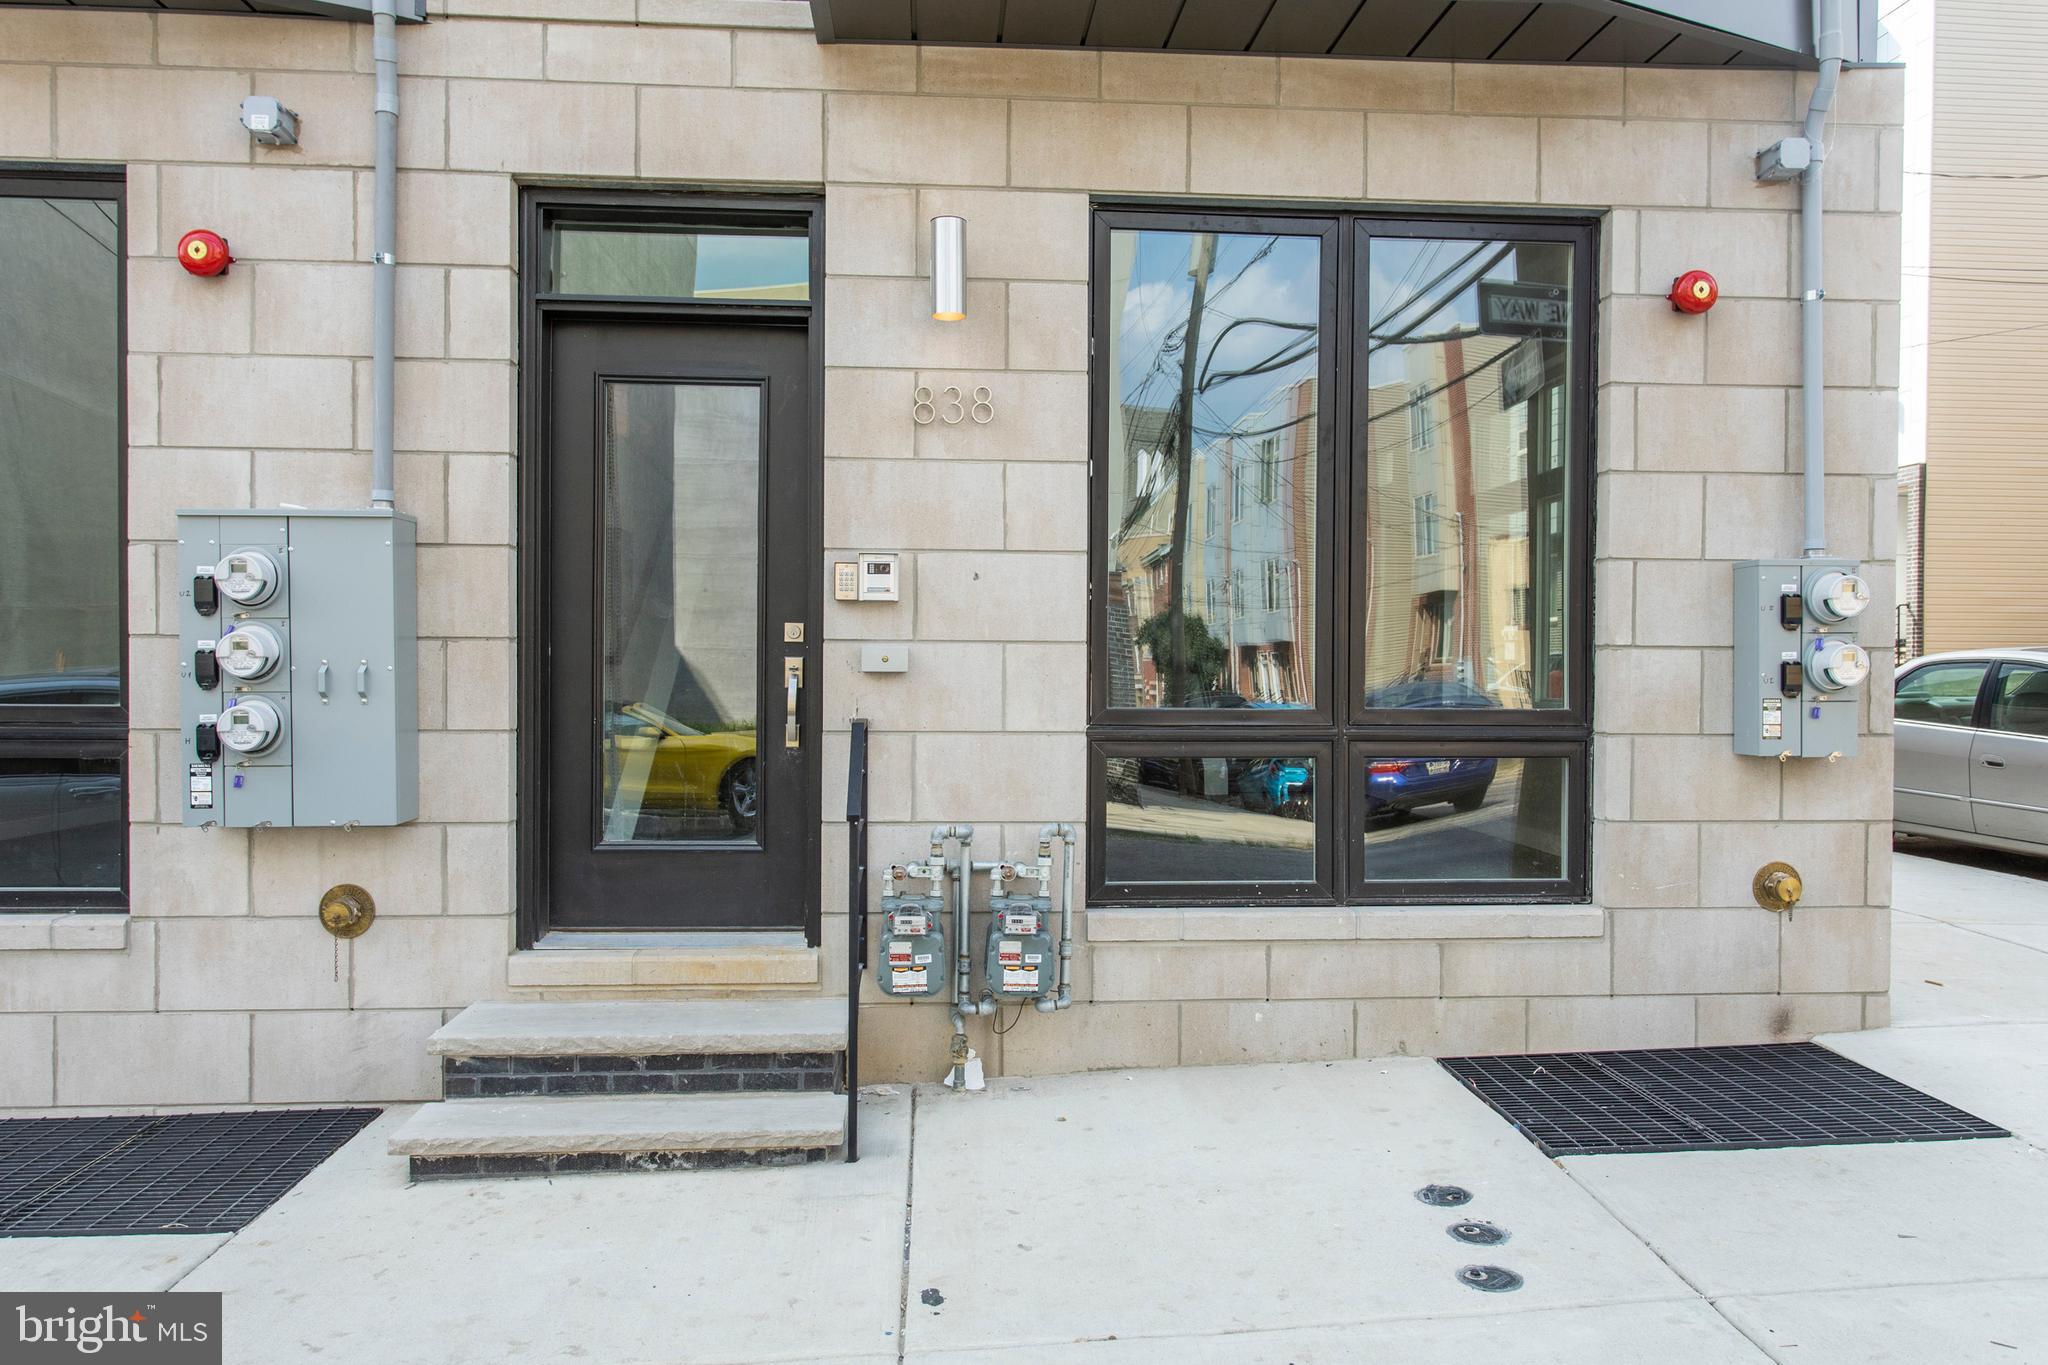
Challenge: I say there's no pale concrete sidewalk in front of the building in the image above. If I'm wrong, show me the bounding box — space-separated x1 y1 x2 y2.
0 857 2048 1365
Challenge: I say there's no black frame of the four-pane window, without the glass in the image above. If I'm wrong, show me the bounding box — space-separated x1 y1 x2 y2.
1087 201 1599 907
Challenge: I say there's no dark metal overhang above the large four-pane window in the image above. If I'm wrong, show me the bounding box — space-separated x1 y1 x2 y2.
811 0 1878 68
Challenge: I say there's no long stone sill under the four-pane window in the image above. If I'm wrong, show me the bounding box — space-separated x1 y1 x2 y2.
1087 905 1608 943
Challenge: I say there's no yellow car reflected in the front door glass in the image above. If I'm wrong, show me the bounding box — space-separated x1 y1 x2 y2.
604 702 760 831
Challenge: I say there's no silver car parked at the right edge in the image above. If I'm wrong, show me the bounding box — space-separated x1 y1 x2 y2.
1892 647 2048 853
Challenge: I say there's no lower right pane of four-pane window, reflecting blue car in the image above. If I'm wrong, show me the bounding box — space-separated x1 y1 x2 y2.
1358 755 1569 882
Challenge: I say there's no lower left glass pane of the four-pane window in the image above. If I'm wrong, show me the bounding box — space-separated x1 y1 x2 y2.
1102 755 1317 886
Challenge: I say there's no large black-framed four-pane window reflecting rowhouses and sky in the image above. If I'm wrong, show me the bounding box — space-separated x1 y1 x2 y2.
1090 211 1593 905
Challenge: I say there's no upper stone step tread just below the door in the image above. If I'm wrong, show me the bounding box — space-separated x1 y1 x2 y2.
426 999 846 1058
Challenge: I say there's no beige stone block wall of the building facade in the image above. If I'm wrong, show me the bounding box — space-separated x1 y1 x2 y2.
0 0 1903 1107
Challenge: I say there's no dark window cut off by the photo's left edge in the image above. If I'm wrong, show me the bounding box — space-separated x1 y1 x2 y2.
0 168 127 911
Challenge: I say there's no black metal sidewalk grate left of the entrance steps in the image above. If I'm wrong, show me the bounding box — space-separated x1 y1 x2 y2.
0 1109 379 1236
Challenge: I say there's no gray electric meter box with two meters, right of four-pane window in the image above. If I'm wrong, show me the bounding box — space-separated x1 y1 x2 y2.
1733 559 1870 759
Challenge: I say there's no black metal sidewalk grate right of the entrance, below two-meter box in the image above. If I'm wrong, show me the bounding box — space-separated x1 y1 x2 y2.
1442 1044 2011 1156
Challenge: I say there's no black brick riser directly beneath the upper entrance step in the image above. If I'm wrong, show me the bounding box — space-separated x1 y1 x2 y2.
440 1052 840 1099
